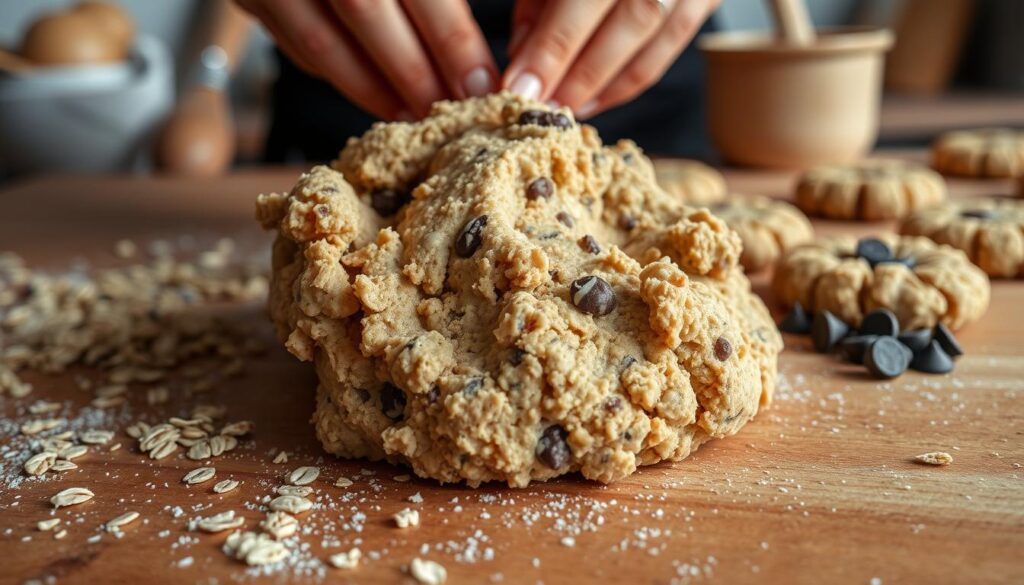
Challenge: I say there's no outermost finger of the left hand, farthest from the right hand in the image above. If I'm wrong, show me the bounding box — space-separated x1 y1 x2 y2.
237 0 406 120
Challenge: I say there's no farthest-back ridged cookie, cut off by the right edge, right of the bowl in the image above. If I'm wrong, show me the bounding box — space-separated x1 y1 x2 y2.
932 128 1024 178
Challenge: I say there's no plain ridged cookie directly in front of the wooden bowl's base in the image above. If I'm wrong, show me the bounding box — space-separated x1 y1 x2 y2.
797 159 946 220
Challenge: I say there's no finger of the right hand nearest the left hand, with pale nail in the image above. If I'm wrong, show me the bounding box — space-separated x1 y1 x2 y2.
504 0 614 99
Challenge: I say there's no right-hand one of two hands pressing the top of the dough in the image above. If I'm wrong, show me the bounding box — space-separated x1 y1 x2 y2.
503 0 721 118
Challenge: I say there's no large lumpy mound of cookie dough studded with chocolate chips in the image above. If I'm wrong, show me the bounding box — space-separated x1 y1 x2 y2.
257 94 781 486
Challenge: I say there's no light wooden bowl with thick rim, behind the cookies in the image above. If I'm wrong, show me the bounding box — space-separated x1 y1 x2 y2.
699 28 893 168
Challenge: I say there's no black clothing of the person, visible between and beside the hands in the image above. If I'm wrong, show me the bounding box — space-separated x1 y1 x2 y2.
265 0 709 163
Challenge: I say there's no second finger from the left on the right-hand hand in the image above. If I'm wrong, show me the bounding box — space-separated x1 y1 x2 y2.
552 0 668 116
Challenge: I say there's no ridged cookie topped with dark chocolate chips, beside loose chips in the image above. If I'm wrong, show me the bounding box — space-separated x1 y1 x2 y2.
772 235 990 330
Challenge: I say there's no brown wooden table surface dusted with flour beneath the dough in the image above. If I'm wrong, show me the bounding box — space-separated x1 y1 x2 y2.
0 155 1024 585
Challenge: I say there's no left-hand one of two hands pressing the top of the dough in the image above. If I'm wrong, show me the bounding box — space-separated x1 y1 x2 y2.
237 0 498 120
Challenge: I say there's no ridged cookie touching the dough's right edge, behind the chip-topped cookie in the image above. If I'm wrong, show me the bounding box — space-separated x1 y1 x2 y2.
711 195 814 271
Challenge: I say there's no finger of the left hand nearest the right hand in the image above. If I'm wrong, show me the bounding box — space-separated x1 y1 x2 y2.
402 0 498 99
